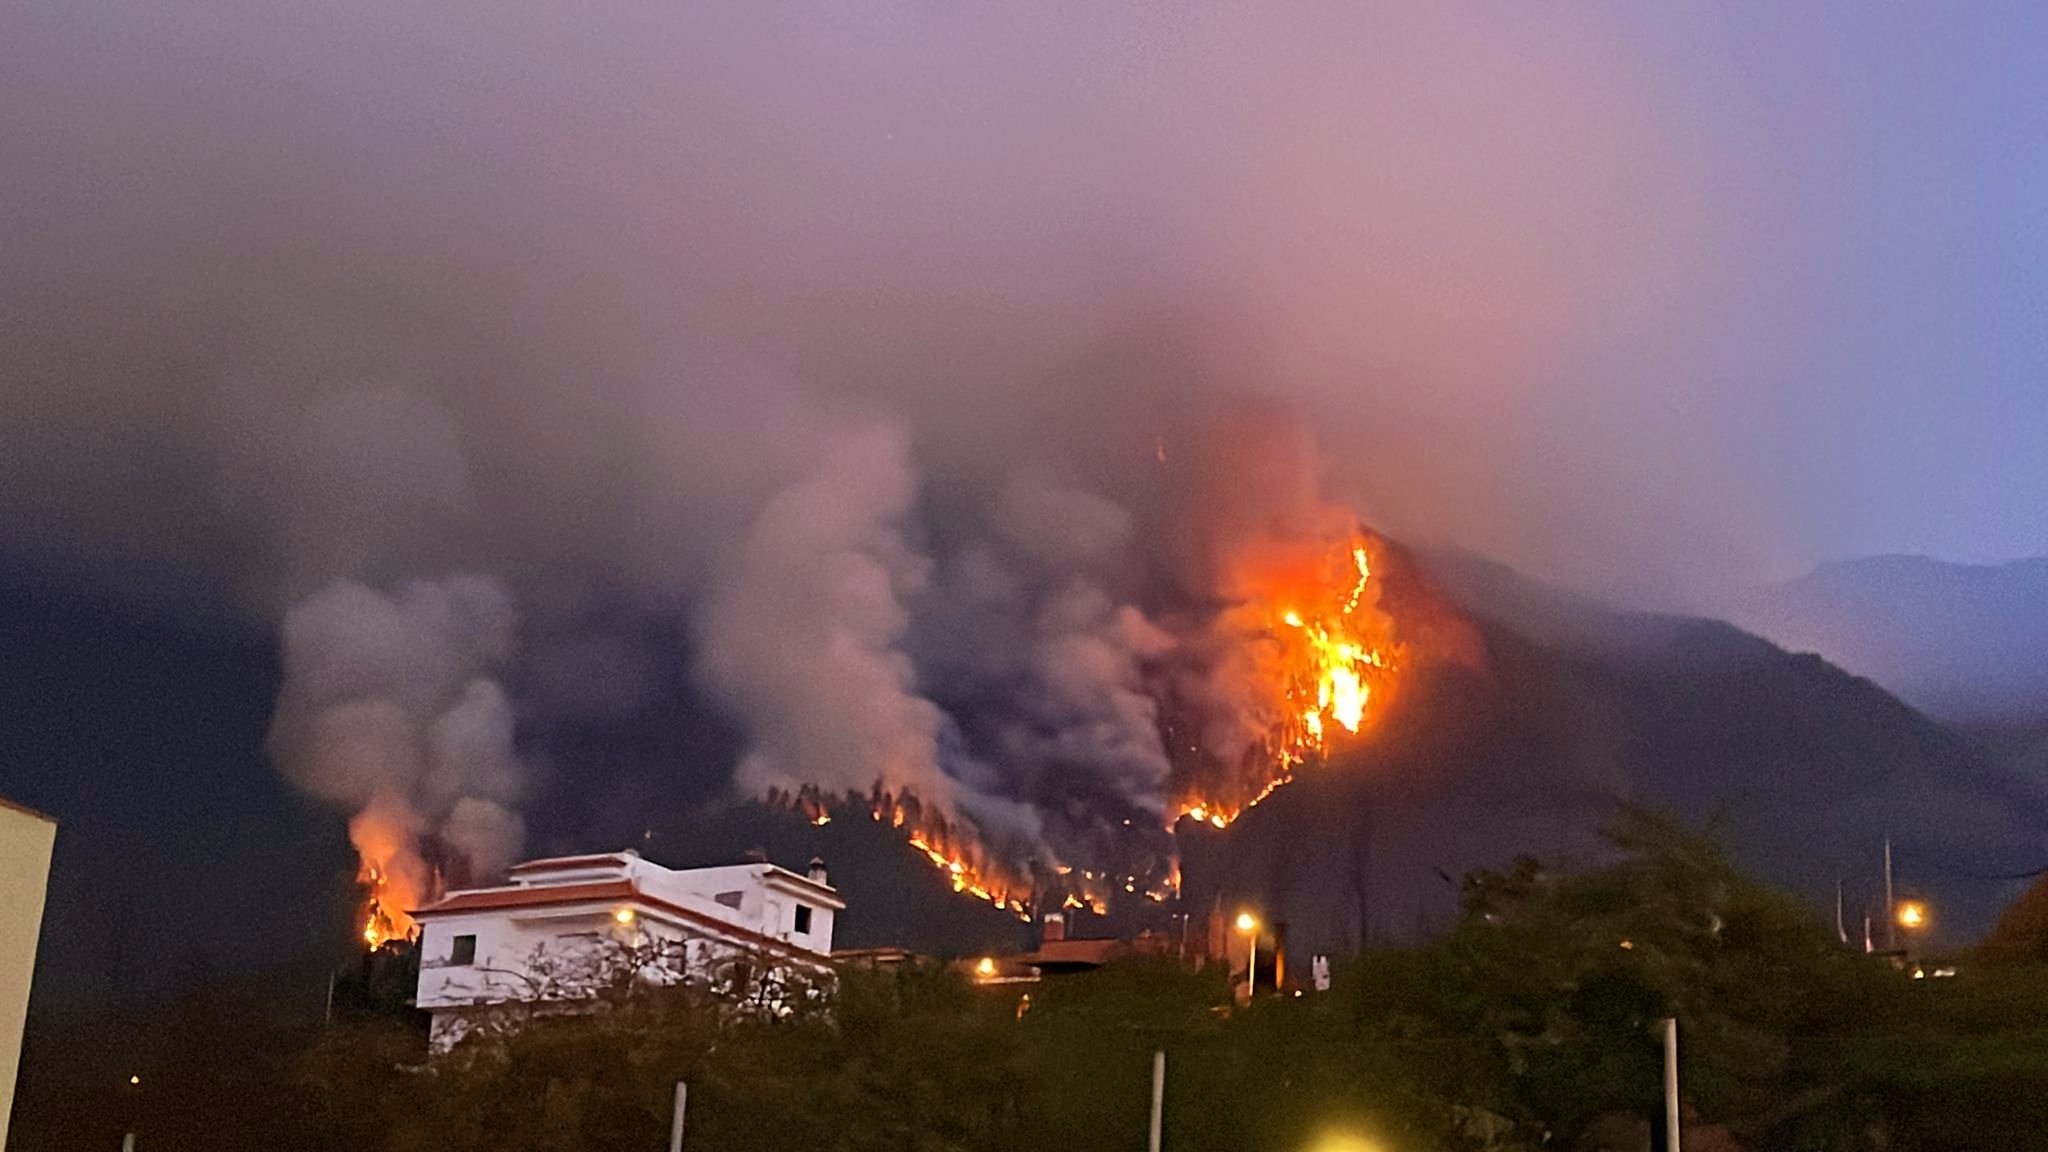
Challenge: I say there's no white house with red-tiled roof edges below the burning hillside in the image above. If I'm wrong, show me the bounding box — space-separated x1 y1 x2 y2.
412 849 846 1052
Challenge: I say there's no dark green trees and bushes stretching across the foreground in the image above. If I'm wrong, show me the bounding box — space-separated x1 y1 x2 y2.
16 814 2048 1152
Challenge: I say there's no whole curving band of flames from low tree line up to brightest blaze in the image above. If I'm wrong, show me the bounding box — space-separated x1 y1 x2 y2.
768 506 1405 918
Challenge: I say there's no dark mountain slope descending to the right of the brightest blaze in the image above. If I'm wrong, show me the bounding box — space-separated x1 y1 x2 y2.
1184 553 2048 949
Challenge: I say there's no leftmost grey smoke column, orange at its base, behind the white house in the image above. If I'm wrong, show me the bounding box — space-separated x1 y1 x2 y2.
268 576 524 877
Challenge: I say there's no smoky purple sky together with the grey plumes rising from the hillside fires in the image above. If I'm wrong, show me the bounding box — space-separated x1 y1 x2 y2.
0 0 2048 897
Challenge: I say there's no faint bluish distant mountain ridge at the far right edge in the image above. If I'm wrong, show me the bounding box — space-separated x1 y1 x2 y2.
1729 556 2048 726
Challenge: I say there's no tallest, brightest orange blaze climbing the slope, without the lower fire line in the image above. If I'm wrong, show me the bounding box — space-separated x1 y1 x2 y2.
1176 533 1401 828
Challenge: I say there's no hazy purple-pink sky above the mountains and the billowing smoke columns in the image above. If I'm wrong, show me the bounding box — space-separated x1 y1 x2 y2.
0 0 2048 609
